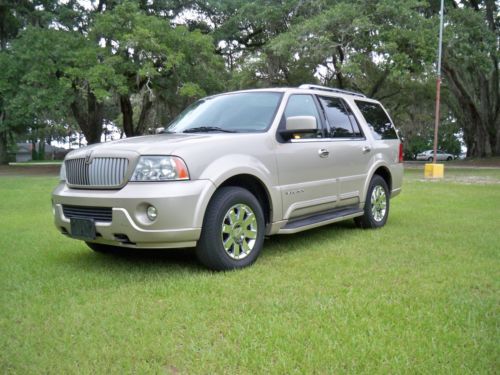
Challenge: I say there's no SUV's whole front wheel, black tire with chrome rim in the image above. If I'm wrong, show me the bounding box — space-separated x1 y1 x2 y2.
196 186 265 271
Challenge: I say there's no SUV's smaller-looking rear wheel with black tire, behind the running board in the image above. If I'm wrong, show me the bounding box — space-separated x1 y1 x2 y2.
354 175 390 229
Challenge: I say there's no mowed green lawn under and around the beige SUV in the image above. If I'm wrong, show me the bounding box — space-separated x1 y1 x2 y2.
0 169 500 374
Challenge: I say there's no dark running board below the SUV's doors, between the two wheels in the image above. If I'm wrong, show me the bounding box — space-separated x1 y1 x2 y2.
278 206 363 234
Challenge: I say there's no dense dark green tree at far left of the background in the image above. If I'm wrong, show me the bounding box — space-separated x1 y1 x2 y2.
1 27 109 147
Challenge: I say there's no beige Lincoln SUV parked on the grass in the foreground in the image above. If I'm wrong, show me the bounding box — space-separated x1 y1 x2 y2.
52 85 403 270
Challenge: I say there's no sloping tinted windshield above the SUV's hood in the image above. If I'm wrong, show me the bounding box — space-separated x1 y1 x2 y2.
166 92 282 133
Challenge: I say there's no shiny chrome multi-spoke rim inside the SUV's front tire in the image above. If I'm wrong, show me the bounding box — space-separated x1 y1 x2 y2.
221 204 258 259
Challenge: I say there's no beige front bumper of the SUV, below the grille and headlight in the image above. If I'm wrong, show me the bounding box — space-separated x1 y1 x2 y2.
52 180 215 248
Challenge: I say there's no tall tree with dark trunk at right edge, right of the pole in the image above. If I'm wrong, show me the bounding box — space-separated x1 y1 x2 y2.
443 0 500 157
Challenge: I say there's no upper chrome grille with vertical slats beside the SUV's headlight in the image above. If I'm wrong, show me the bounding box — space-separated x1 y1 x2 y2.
65 157 128 187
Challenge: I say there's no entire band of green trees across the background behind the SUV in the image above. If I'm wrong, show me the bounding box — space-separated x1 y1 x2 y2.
0 0 500 164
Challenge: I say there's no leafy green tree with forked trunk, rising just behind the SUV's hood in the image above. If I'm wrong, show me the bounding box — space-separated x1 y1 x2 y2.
91 2 224 137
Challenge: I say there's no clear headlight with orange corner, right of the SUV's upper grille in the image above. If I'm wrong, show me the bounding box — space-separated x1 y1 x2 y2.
130 156 189 181
